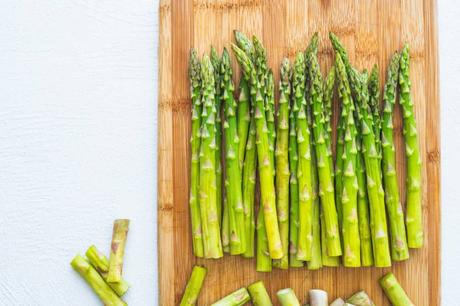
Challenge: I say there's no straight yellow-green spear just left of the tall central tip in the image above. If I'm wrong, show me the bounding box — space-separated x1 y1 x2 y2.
293 52 313 261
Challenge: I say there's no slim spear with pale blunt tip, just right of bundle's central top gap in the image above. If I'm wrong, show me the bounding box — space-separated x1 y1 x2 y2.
273 58 291 269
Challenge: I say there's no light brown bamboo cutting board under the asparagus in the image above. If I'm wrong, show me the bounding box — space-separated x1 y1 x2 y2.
158 0 440 306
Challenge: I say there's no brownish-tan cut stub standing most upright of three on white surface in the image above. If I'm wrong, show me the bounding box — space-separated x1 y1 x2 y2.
107 219 129 283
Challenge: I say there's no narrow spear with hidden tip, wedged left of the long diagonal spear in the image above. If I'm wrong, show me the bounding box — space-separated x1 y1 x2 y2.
243 117 256 258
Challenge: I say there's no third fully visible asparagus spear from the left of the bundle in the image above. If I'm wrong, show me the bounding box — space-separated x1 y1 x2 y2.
220 49 246 255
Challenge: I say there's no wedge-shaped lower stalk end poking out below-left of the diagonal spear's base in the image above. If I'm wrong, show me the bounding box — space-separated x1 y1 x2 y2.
256 207 272 272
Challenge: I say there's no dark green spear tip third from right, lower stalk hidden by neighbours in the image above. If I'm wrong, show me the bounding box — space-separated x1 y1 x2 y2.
367 65 382 158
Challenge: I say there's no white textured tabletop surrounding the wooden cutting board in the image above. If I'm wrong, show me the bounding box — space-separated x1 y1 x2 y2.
0 0 460 306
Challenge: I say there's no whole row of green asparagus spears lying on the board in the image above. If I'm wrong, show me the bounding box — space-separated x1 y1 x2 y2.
189 31 423 272
